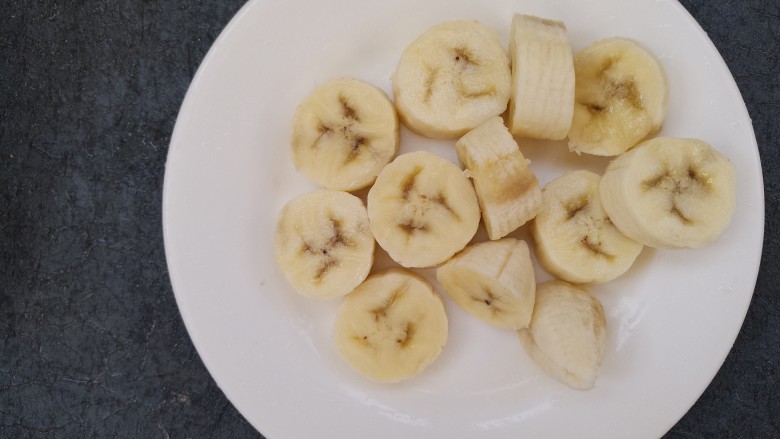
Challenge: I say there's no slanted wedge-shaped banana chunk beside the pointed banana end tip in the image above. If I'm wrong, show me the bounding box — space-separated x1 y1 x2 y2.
436 238 536 329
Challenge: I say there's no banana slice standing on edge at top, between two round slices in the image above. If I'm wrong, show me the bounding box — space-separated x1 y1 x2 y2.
507 14 574 140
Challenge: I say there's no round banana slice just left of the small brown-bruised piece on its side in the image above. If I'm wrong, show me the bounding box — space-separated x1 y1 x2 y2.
368 151 479 267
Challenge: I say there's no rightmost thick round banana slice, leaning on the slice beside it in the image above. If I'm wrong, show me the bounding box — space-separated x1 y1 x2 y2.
600 137 736 248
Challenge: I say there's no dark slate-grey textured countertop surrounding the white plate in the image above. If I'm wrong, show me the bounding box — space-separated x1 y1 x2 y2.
0 0 780 439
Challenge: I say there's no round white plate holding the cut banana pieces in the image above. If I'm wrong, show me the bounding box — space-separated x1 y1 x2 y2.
163 0 764 439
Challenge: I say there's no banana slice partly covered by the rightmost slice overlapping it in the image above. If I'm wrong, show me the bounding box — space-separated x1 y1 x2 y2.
531 171 642 283
